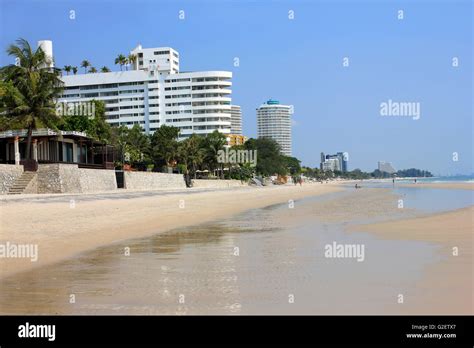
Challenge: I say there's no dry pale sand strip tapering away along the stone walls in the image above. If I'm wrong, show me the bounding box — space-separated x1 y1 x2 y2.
0 183 342 278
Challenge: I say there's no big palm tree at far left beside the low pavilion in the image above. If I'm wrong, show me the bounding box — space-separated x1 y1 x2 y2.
0 39 63 160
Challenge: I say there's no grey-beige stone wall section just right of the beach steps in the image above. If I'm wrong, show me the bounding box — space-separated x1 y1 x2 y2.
37 163 117 193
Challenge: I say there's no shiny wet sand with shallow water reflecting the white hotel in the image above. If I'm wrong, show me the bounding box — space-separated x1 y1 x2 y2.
0 190 462 314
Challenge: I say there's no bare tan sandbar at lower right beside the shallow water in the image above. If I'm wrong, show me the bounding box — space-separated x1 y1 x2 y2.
352 206 474 315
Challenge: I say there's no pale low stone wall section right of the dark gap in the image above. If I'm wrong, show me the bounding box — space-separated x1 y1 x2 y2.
124 171 186 190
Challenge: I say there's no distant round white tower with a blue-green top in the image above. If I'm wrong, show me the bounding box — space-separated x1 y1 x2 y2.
257 99 292 156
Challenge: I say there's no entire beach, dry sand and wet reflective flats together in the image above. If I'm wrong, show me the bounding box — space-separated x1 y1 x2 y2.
0 182 474 315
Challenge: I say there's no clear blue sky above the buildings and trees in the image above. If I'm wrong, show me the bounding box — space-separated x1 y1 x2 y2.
0 0 474 174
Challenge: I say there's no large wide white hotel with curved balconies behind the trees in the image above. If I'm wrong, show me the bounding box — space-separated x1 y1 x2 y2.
56 40 232 139
